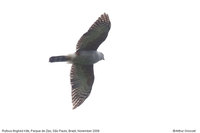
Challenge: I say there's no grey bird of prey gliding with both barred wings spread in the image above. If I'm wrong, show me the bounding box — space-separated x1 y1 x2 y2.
49 13 111 109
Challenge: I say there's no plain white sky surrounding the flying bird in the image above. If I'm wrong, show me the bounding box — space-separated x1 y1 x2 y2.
0 0 200 133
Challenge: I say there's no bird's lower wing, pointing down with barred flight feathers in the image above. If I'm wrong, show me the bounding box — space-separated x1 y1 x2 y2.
70 64 94 109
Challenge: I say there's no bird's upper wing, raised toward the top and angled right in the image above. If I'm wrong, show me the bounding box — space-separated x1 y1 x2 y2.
76 13 111 51
